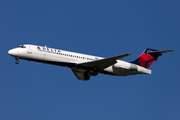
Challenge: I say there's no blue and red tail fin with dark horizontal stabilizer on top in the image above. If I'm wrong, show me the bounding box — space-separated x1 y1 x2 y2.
130 48 175 68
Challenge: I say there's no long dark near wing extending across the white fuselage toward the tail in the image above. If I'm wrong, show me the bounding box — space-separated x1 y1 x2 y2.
77 53 131 71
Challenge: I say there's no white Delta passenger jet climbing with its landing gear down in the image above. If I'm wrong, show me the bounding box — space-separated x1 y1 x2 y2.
8 44 175 81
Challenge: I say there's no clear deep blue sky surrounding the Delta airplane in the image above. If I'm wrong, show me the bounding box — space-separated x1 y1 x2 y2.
0 0 180 120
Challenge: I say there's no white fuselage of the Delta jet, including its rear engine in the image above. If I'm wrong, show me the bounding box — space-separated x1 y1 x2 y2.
8 44 151 76
